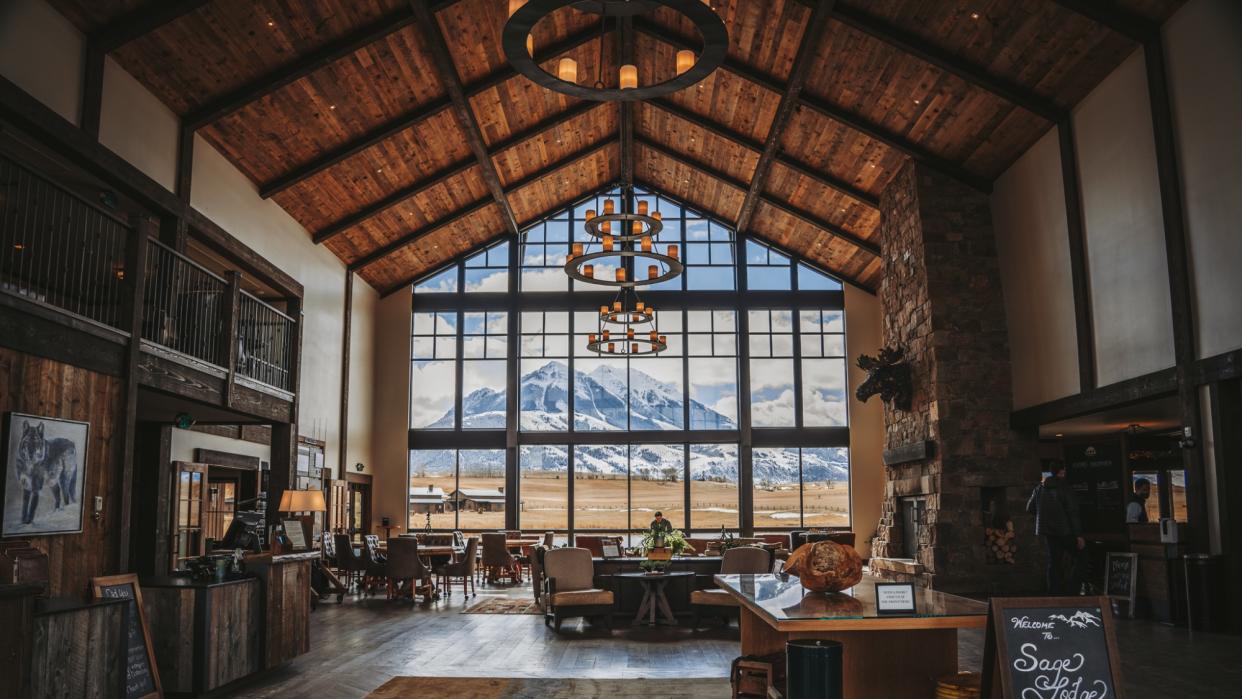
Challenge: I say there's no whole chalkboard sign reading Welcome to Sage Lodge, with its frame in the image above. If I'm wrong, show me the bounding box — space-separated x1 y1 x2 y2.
981 597 1125 699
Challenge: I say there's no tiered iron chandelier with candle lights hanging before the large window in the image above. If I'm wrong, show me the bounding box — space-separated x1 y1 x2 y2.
565 193 684 356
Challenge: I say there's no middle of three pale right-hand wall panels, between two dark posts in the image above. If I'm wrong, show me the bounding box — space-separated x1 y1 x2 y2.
1073 51 1174 386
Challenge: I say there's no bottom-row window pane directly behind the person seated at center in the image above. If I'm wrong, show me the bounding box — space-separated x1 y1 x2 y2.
630 444 686 540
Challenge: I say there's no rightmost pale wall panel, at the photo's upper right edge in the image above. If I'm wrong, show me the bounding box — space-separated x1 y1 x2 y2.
1164 0 1242 356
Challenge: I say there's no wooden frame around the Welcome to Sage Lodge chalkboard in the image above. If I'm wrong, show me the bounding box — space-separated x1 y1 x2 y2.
980 597 1125 699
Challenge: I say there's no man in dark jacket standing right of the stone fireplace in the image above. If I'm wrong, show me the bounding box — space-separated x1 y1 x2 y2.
1026 462 1087 595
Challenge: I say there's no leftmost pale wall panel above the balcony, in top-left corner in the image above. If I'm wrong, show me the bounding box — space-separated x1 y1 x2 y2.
0 0 82 124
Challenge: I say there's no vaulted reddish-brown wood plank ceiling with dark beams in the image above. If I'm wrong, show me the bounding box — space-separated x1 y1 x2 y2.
53 0 1180 291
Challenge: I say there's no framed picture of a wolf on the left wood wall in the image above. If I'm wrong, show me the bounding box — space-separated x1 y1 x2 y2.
0 412 91 536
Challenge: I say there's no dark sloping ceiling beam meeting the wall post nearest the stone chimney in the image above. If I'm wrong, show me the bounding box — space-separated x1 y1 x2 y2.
832 5 1066 123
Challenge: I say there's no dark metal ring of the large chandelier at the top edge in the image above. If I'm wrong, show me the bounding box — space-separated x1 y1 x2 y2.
501 0 729 102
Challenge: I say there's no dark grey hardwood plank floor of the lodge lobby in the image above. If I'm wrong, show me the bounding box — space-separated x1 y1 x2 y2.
229 586 1242 699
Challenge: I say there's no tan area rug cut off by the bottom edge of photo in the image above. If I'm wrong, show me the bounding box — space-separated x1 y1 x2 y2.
366 677 732 699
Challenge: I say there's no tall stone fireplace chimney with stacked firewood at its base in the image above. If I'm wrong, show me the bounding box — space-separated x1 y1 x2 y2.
872 163 1042 593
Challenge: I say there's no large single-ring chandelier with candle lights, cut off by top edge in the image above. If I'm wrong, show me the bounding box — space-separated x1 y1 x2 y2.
501 0 729 102
